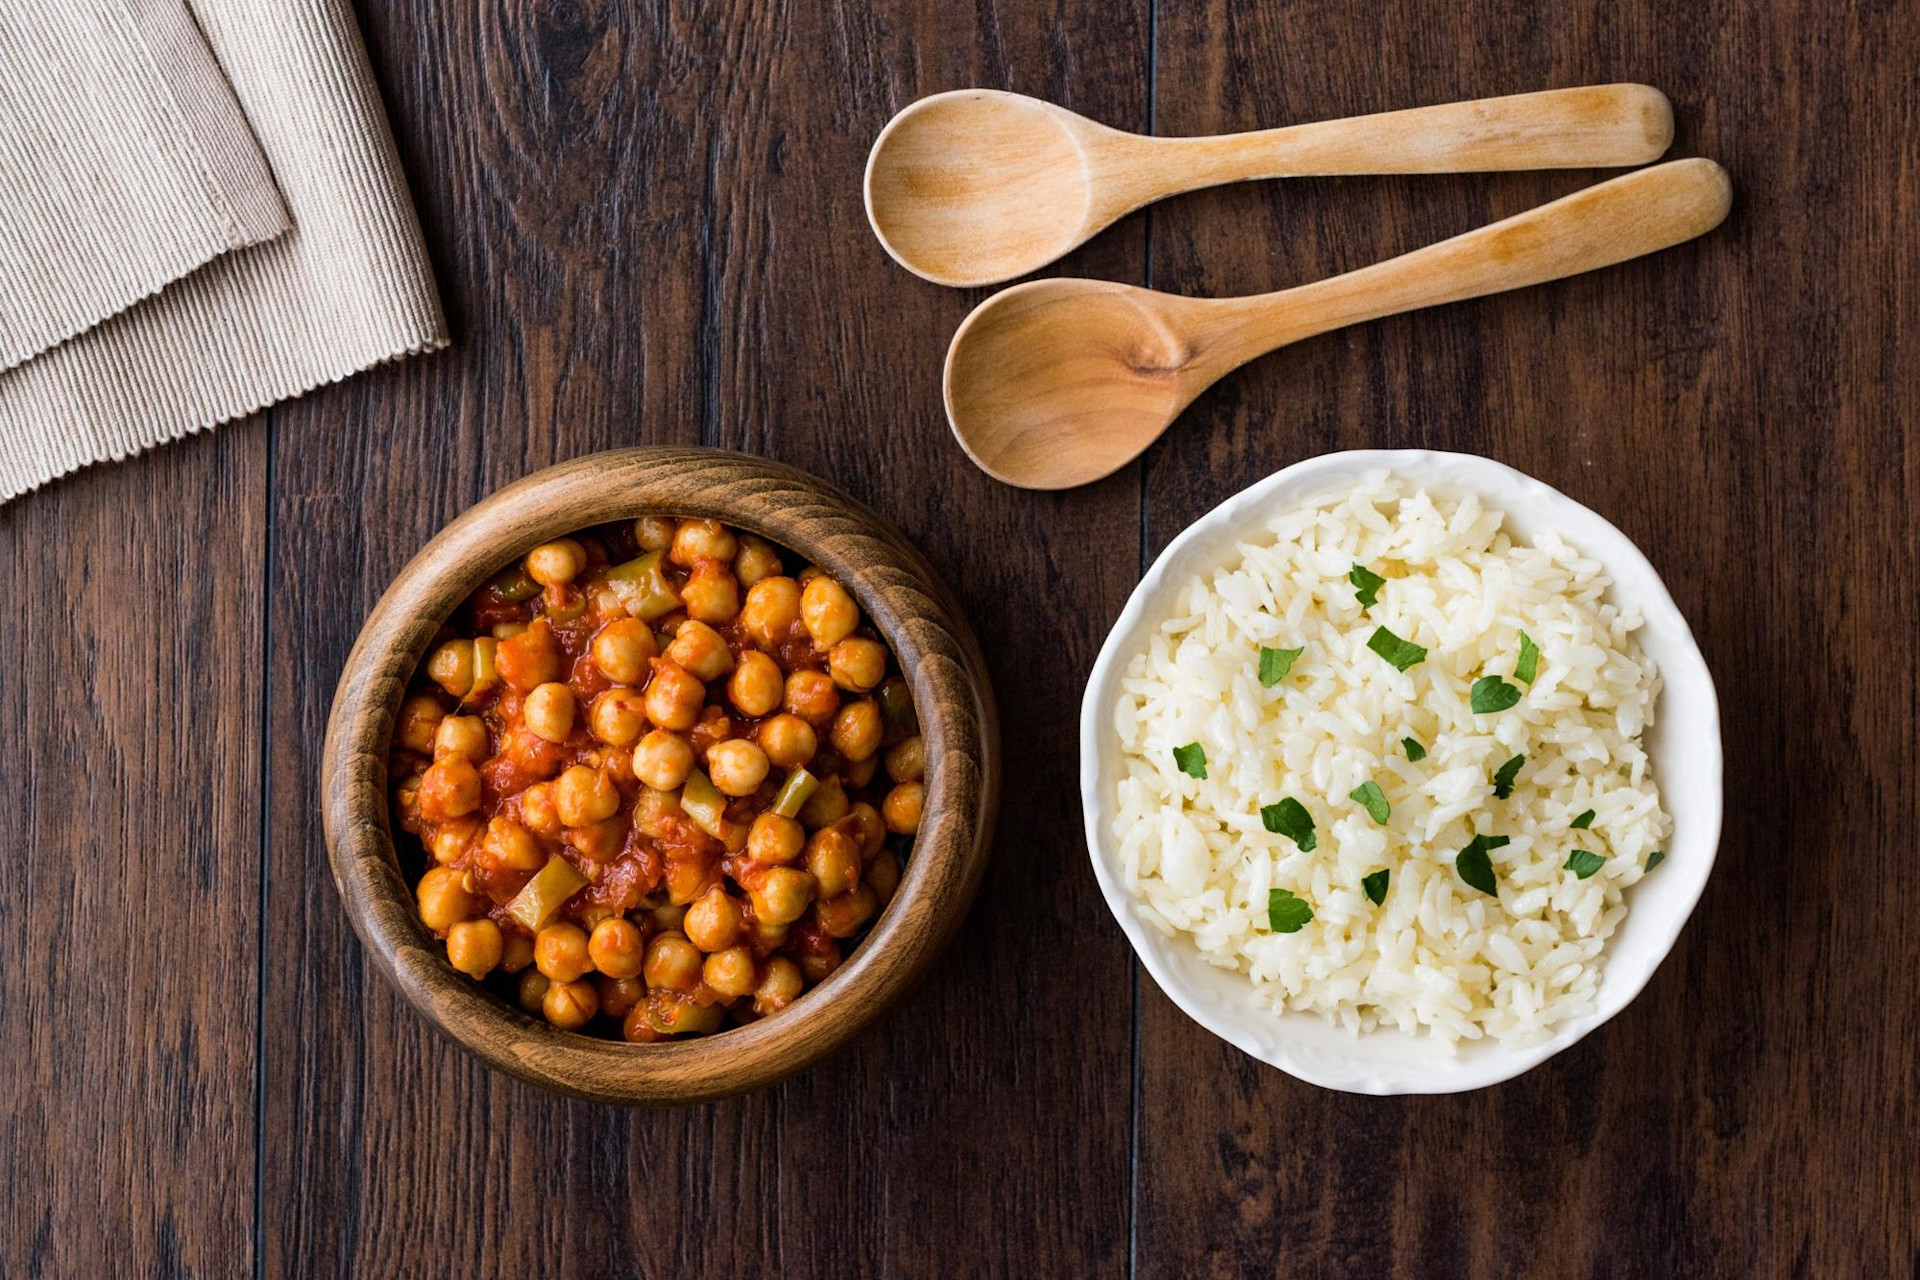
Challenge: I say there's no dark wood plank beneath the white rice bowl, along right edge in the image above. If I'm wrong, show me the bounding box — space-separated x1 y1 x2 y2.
1137 0 1920 1276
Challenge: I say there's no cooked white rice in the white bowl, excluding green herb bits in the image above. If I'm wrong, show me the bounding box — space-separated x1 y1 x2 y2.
1114 472 1670 1046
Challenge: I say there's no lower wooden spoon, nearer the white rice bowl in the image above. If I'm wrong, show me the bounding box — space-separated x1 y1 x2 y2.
947 159 1732 489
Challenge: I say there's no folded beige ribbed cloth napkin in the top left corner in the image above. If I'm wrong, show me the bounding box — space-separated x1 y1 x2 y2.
0 0 445 501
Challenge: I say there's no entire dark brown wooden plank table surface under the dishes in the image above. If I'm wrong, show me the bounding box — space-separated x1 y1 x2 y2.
0 0 1920 1280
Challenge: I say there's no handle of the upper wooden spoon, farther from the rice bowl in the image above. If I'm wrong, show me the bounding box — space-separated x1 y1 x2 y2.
1142 84 1674 194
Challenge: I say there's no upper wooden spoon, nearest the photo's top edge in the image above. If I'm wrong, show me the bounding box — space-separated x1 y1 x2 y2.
866 84 1674 286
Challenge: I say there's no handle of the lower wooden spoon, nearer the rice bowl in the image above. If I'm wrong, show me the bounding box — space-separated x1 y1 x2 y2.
1187 159 1732 376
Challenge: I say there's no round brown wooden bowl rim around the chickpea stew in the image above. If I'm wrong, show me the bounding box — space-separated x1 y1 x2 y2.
321 447 998 1103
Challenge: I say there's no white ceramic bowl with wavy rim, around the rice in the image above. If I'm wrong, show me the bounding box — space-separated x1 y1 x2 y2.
1081 449 1720 1094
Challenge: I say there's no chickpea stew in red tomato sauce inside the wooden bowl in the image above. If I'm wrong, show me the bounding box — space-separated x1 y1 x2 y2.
388 516 925 1042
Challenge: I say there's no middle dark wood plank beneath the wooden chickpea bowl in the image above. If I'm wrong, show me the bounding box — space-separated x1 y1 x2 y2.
263 2 1146 1276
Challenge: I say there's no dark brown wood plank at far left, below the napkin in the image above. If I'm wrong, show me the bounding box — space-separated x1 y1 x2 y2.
0 420 267 1276
